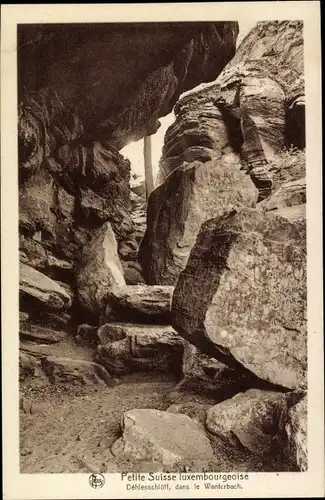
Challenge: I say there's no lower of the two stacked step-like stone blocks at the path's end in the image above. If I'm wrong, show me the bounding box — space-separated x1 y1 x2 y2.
97 323 183 374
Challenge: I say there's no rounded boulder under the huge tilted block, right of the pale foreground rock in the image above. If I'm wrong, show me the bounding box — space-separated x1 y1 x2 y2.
206 389 294 454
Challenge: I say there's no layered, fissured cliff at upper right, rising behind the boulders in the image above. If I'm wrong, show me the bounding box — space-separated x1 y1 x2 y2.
160 21 305 181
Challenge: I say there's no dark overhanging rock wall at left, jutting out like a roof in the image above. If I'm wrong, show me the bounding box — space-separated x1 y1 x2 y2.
18 22 238 320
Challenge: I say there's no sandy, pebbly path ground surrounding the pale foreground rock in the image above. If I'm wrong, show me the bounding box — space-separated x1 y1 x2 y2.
20 373 283 473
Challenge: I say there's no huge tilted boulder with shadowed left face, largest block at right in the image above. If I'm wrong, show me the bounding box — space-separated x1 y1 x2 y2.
171 209 307 389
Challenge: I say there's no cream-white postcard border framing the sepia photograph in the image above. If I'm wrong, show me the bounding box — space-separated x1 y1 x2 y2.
1 1 324 500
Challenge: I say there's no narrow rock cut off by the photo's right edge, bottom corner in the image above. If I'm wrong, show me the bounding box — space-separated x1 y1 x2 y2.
285 396 308 471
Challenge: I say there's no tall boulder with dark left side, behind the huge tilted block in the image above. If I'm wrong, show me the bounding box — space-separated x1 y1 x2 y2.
139 160 258 285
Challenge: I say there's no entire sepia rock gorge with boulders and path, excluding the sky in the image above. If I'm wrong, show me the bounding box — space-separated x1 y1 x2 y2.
18 21 308 473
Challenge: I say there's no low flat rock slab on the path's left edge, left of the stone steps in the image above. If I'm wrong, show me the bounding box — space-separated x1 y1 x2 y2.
42 356 116 386
